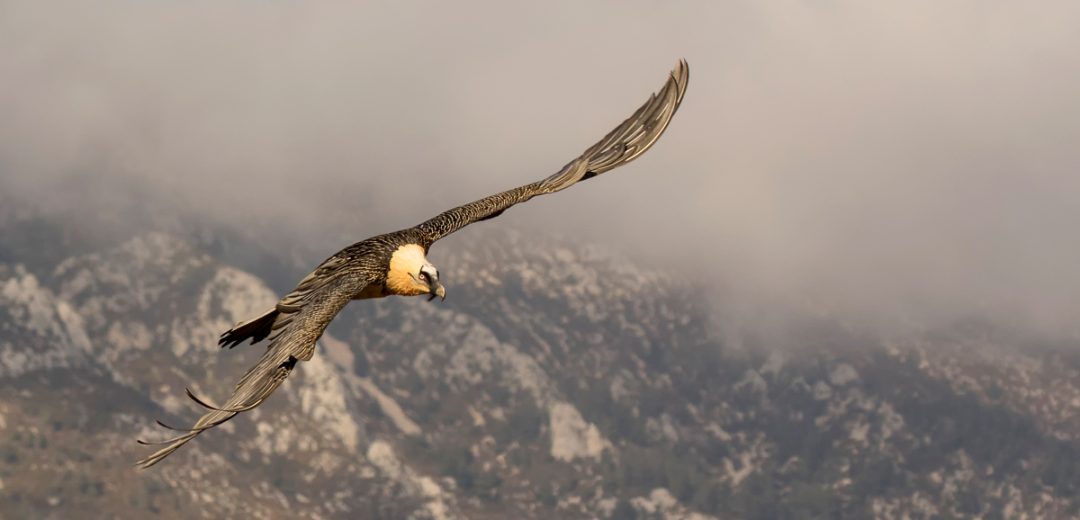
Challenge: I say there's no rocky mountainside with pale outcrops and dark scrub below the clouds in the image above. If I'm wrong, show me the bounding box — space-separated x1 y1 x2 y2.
0 214 1080 519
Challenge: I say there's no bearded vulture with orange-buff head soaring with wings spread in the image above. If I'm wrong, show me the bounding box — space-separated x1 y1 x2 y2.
136 61 690 468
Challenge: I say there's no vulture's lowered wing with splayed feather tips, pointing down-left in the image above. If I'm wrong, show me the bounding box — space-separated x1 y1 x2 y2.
137 257 375 468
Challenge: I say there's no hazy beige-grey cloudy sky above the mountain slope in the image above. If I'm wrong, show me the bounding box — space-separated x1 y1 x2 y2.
0 0 1080 333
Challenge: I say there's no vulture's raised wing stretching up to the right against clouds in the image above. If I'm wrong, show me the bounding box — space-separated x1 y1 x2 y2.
417 61 690 244
